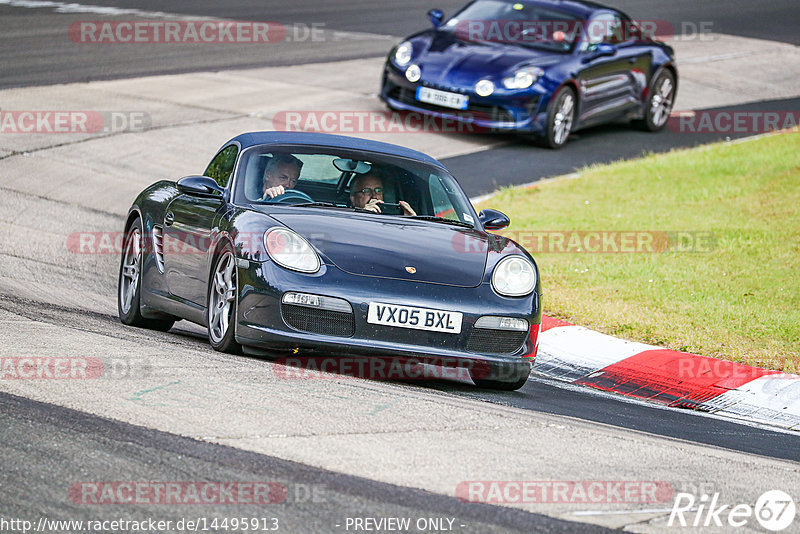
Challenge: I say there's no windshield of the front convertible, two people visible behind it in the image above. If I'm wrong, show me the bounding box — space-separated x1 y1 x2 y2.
234 145 477 227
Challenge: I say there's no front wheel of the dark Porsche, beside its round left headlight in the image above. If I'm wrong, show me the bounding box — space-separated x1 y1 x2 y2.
206 245 242 354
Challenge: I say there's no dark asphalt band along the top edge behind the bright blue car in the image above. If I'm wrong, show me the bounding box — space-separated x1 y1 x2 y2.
0 0 800 88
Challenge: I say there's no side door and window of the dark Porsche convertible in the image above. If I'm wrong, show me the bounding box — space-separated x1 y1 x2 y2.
164 145 239 307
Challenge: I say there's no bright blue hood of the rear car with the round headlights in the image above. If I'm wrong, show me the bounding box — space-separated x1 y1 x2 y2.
415 32 563 86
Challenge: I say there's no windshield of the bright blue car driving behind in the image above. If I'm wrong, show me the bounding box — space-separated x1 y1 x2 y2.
443 0 583 52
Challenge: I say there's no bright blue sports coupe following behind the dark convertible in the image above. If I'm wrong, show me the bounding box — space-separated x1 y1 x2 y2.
380 0 678 148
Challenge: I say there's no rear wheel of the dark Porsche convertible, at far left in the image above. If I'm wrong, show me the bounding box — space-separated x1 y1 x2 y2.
117 217 175 332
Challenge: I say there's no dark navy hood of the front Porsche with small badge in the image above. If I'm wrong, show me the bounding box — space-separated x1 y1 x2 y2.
270 213 487 287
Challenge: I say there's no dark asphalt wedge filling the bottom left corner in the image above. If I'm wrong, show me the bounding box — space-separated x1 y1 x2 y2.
0 393 607 533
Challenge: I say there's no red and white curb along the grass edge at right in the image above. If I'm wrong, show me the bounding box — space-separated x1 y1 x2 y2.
533 316 800 431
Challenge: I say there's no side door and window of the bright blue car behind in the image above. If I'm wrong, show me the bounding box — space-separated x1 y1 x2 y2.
578 11 642 125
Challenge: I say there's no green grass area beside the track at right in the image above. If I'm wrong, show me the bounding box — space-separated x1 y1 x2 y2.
478 133 800 373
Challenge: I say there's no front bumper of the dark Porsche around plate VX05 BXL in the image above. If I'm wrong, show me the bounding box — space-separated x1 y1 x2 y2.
236 259 541 375
